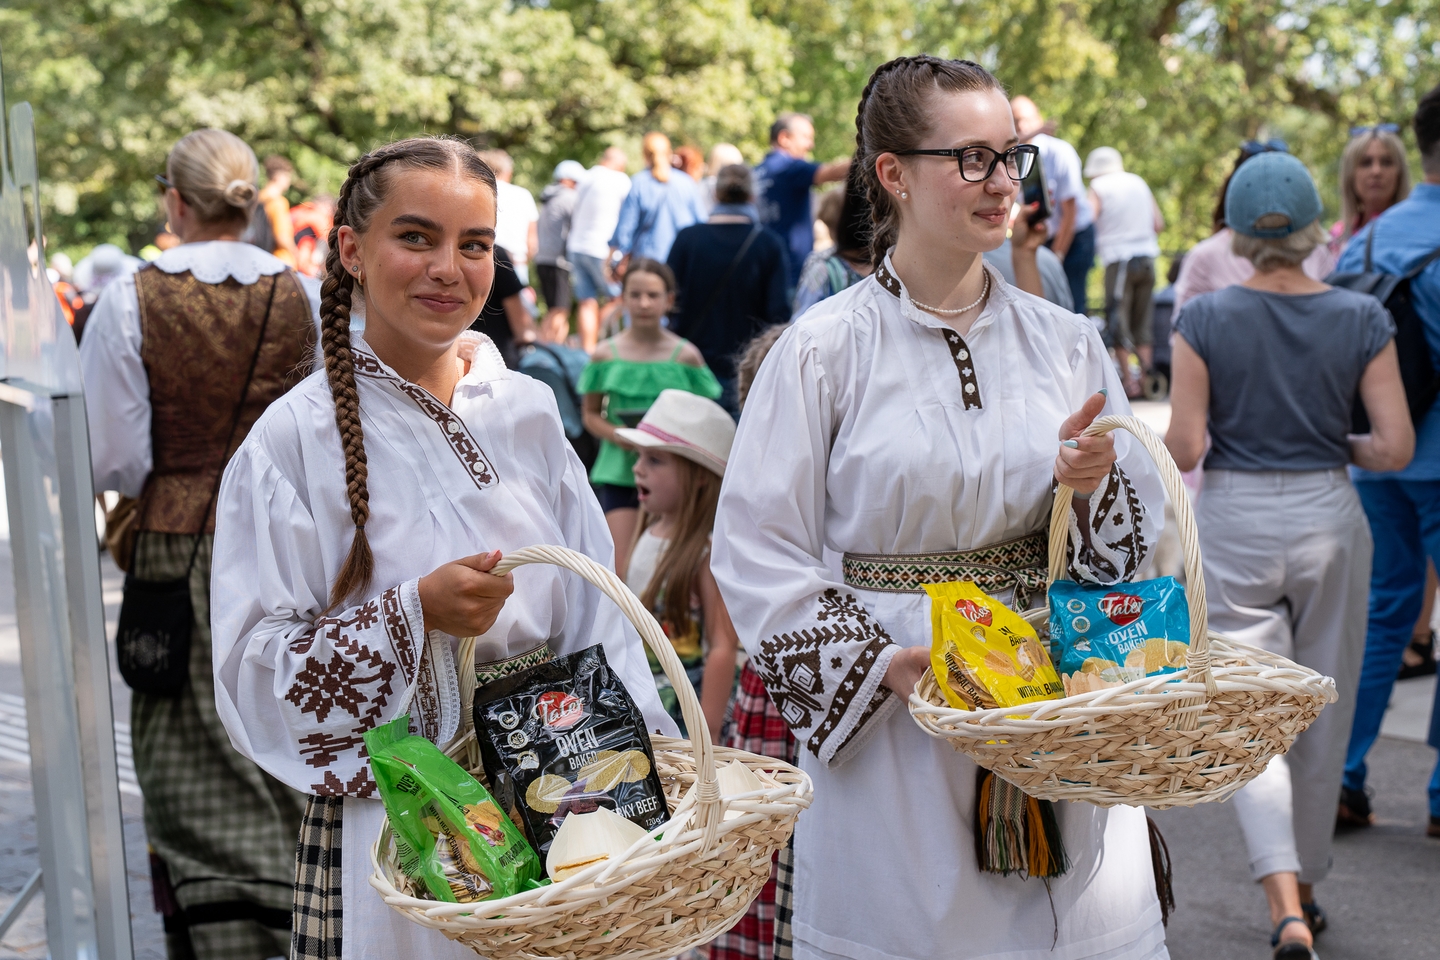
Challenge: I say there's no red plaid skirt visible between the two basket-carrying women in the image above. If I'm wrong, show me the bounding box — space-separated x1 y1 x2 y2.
710 664 798 960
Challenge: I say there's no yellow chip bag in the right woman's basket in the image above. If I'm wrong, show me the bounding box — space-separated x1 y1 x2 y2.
924 581 1064 710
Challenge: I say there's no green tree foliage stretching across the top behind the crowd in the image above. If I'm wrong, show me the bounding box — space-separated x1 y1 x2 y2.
0 0 1440 250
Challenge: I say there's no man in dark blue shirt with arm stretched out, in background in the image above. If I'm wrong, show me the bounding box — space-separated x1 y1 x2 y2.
755 114 850 289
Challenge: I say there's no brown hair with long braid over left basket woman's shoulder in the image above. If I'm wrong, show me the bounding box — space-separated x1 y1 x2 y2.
320 137 495 609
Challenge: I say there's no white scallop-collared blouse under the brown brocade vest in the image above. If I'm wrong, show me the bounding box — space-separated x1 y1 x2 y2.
81 240 320 497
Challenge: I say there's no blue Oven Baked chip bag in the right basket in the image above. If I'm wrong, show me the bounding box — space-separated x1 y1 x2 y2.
1050 577 1189 697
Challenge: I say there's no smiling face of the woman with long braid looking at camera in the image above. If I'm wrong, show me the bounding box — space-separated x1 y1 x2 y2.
338 167 495 357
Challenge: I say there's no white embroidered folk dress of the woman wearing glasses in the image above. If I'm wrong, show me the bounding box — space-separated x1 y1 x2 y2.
711 259 1168 960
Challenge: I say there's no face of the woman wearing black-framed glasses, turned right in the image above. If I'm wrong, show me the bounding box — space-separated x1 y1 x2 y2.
876 89 1020 253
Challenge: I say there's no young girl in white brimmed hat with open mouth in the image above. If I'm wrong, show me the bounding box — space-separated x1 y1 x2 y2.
616 390 740 743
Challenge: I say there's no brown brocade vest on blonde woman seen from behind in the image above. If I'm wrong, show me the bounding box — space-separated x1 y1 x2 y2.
135 266 315 534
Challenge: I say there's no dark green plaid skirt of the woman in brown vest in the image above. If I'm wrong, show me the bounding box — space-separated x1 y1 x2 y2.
130 531 305 960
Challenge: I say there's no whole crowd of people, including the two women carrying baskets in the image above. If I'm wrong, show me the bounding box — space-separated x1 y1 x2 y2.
36 48 1440 960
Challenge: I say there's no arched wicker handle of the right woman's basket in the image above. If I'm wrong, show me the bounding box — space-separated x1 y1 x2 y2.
1050 416 1218 697
